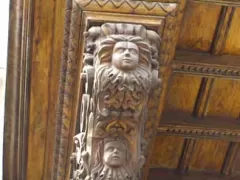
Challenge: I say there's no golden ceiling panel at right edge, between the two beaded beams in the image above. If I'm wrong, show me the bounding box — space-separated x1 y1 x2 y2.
207 79 240 118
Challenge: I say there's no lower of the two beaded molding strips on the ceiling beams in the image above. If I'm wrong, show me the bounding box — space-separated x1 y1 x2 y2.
158 125 240 142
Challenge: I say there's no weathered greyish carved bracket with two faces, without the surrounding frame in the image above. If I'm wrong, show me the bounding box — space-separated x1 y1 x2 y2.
71 23 161 180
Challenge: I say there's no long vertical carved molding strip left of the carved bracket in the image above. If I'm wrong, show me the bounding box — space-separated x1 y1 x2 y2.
52 0 81 180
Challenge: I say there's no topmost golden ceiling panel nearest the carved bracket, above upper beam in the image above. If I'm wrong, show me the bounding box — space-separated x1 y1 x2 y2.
178 1 221 51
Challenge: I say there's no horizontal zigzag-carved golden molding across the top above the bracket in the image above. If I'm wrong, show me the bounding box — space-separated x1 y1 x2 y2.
76 0 179 16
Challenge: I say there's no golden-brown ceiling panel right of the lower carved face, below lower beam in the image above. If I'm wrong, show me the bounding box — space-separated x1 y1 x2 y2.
151 136 184 168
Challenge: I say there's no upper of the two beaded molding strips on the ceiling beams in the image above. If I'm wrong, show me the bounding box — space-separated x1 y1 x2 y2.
172 61 240 79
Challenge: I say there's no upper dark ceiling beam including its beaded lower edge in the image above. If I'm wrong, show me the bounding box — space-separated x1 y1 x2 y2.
172 50 240 79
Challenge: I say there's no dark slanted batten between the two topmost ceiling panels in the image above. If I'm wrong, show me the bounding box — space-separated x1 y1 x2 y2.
211 6 235 55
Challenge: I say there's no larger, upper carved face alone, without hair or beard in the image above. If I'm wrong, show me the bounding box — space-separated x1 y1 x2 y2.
112 41 139 71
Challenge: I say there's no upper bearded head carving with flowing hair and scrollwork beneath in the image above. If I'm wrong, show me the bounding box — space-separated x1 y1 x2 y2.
95 35 152 119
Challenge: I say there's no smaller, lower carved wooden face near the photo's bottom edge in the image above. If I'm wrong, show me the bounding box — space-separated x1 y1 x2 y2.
103 141 126 167
